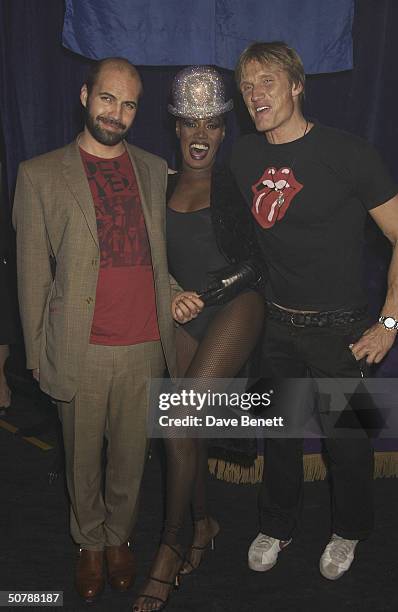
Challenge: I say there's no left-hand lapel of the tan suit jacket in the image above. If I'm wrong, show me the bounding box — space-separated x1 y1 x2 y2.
63 141 99 246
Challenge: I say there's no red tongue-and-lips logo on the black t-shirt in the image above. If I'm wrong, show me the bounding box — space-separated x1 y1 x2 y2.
252 168 303 229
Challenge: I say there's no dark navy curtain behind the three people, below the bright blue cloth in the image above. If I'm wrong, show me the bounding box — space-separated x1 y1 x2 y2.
0 0 398 376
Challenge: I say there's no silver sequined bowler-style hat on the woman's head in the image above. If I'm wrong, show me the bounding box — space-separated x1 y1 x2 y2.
168 66 233 119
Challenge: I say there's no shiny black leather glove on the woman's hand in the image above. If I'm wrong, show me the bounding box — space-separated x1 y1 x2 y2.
199 261 261 306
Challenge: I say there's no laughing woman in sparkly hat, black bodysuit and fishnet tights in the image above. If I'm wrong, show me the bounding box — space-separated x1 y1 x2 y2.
133 66 264 612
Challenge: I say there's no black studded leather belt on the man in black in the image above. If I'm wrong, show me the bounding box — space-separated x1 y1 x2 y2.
267 302 368 327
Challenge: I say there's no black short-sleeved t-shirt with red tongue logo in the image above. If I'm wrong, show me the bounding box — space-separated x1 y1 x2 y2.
231 124 398 310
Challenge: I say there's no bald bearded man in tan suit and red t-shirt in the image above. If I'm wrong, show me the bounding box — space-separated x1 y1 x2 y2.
14 58 180 601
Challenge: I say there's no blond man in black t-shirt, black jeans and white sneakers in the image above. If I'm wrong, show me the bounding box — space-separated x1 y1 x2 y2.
231 42 398 580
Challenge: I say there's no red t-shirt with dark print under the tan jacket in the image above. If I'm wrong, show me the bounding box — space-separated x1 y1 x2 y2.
80 149 159 346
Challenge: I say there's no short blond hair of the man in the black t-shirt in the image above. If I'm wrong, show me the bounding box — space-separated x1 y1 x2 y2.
235 40 305 101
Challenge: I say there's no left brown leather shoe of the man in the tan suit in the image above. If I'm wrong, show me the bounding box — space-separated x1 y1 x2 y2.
75 549 105 603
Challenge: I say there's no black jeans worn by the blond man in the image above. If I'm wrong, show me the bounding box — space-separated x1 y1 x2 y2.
259 320 373 540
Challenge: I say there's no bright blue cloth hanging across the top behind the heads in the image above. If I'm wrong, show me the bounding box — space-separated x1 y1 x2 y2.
63 0 354 74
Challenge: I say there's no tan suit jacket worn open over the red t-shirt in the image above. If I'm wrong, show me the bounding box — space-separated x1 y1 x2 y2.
13 141 177 401
